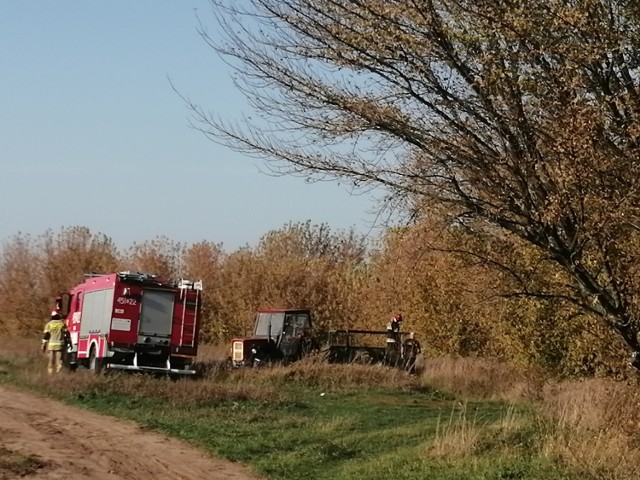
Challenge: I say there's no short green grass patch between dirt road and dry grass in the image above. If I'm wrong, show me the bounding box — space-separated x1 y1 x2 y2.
67 379 577 480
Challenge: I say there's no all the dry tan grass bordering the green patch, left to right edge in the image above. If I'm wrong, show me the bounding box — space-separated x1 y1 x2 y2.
7 339 640 480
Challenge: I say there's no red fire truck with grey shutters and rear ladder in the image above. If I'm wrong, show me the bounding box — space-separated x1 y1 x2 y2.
58 272 202 375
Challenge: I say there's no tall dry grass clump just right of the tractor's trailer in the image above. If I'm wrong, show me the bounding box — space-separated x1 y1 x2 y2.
421 357 544 402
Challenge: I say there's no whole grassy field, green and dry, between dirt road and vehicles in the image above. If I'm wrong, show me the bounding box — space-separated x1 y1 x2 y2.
0 342 639 480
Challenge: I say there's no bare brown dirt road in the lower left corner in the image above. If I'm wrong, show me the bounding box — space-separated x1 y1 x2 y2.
0 386 257 480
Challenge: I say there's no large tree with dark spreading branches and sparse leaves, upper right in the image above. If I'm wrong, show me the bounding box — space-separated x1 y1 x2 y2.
189 0 640 350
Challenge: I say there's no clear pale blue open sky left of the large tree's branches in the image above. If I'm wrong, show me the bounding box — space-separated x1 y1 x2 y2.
0 0 375 251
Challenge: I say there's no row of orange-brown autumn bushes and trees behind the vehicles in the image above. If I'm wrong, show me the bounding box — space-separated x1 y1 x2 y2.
0 222 627 375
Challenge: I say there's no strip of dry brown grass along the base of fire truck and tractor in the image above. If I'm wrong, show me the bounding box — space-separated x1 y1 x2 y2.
0 339 418 404
